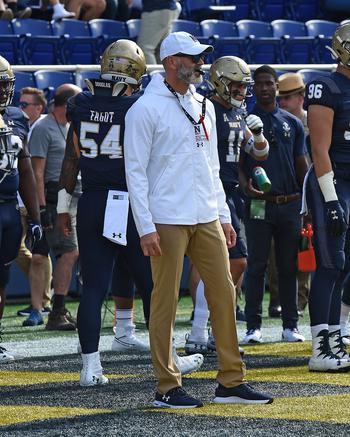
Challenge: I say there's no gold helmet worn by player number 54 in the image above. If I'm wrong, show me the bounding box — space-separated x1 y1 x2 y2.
101 39 146 86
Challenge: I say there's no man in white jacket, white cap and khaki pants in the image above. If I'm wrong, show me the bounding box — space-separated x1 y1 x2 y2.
124 32 272 408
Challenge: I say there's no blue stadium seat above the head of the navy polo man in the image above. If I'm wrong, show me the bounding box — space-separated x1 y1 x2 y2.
236 20 281 64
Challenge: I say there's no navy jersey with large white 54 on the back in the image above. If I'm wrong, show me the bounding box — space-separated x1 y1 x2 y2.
67 91 139 191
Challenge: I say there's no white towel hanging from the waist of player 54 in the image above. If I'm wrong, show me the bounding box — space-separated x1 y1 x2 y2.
103 190 129 246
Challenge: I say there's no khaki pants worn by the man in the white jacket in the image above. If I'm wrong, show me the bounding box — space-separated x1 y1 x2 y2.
149 220 245 394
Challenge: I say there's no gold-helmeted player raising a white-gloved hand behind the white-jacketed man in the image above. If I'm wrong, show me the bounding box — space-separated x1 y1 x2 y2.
185 56 269 353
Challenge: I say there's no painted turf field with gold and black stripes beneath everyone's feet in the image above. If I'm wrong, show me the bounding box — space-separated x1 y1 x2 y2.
0 297 350 437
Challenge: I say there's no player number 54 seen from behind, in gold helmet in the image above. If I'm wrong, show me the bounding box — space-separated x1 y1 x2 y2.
57 40 202 386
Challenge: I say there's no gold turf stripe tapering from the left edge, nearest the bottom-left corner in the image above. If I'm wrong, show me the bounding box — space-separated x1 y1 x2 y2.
0 405 113 426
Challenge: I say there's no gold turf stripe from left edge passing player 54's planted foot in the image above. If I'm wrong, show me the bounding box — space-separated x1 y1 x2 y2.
0 370 139 387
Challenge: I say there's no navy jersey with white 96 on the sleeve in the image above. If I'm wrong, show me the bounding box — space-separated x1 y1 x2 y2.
305 73 350 163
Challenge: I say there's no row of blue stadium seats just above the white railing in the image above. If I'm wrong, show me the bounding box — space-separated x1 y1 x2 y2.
0 19 339 65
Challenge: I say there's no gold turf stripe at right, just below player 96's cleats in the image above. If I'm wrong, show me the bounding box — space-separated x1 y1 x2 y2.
184 366 350 386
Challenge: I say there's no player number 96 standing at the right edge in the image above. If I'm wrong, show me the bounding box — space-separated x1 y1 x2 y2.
305 23 350 372
